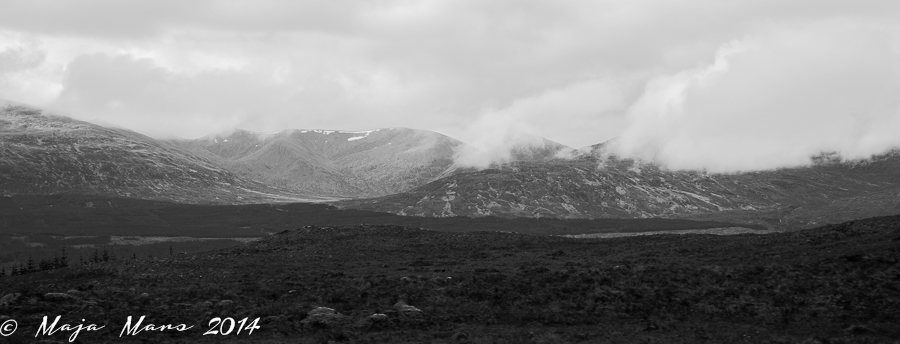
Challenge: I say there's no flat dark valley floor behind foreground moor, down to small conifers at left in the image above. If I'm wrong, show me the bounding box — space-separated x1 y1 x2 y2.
0 195 764 271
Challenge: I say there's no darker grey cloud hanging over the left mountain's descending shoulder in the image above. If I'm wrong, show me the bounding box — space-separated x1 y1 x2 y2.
51 54 277 136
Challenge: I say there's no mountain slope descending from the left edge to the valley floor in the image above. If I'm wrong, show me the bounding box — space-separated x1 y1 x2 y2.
0 104 308 203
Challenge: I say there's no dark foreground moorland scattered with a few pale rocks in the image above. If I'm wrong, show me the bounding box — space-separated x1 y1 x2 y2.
0 216 900 343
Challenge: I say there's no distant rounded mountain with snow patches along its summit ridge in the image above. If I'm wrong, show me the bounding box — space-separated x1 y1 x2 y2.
168 128 462 198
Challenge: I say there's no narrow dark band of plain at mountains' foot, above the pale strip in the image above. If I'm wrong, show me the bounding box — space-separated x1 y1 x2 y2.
0 195 765 238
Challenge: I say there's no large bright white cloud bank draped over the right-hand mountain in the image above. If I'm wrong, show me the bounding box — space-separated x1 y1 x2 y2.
613 21 900 172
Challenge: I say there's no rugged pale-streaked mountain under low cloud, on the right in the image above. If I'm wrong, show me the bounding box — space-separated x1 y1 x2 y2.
336 145 900 228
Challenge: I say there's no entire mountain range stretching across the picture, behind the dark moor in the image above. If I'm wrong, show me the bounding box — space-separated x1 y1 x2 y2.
7 99 900 228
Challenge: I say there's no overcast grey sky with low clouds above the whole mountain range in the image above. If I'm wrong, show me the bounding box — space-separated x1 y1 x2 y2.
0 0 900 172
